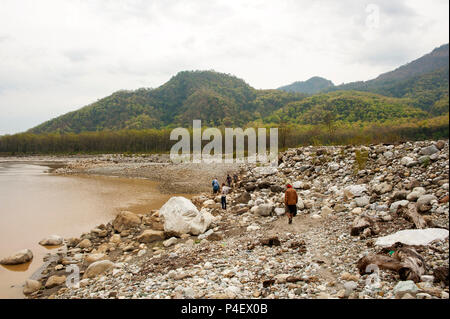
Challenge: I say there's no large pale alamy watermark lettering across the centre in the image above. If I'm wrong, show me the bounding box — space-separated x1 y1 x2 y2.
170 120 278 166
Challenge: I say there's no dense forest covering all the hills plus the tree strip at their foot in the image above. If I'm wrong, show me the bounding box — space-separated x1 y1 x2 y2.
0 45 449 154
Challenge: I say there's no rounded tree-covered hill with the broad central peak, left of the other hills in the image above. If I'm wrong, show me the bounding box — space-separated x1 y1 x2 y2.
30 71 303 133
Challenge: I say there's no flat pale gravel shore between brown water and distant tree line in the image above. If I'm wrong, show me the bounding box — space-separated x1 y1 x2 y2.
0 154 240 194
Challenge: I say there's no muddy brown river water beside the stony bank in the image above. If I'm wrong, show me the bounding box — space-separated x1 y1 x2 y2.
0 162 185 298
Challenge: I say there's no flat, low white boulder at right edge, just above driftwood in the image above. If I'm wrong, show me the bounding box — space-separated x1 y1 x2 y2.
375 228 448 247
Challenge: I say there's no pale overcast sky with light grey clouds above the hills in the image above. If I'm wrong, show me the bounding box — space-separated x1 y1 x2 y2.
0 0 449 135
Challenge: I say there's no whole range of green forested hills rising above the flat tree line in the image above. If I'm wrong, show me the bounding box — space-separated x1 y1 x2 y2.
29 45 449 133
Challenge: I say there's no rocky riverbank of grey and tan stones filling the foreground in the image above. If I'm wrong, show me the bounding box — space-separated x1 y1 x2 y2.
12 140 449 299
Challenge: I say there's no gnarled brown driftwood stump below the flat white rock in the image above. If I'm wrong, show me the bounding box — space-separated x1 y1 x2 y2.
357 243 426 282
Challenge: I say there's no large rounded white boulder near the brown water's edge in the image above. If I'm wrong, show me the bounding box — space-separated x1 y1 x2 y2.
159 197 214 236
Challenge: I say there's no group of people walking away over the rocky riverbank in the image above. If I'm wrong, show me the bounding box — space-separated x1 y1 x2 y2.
212 174 298 224
